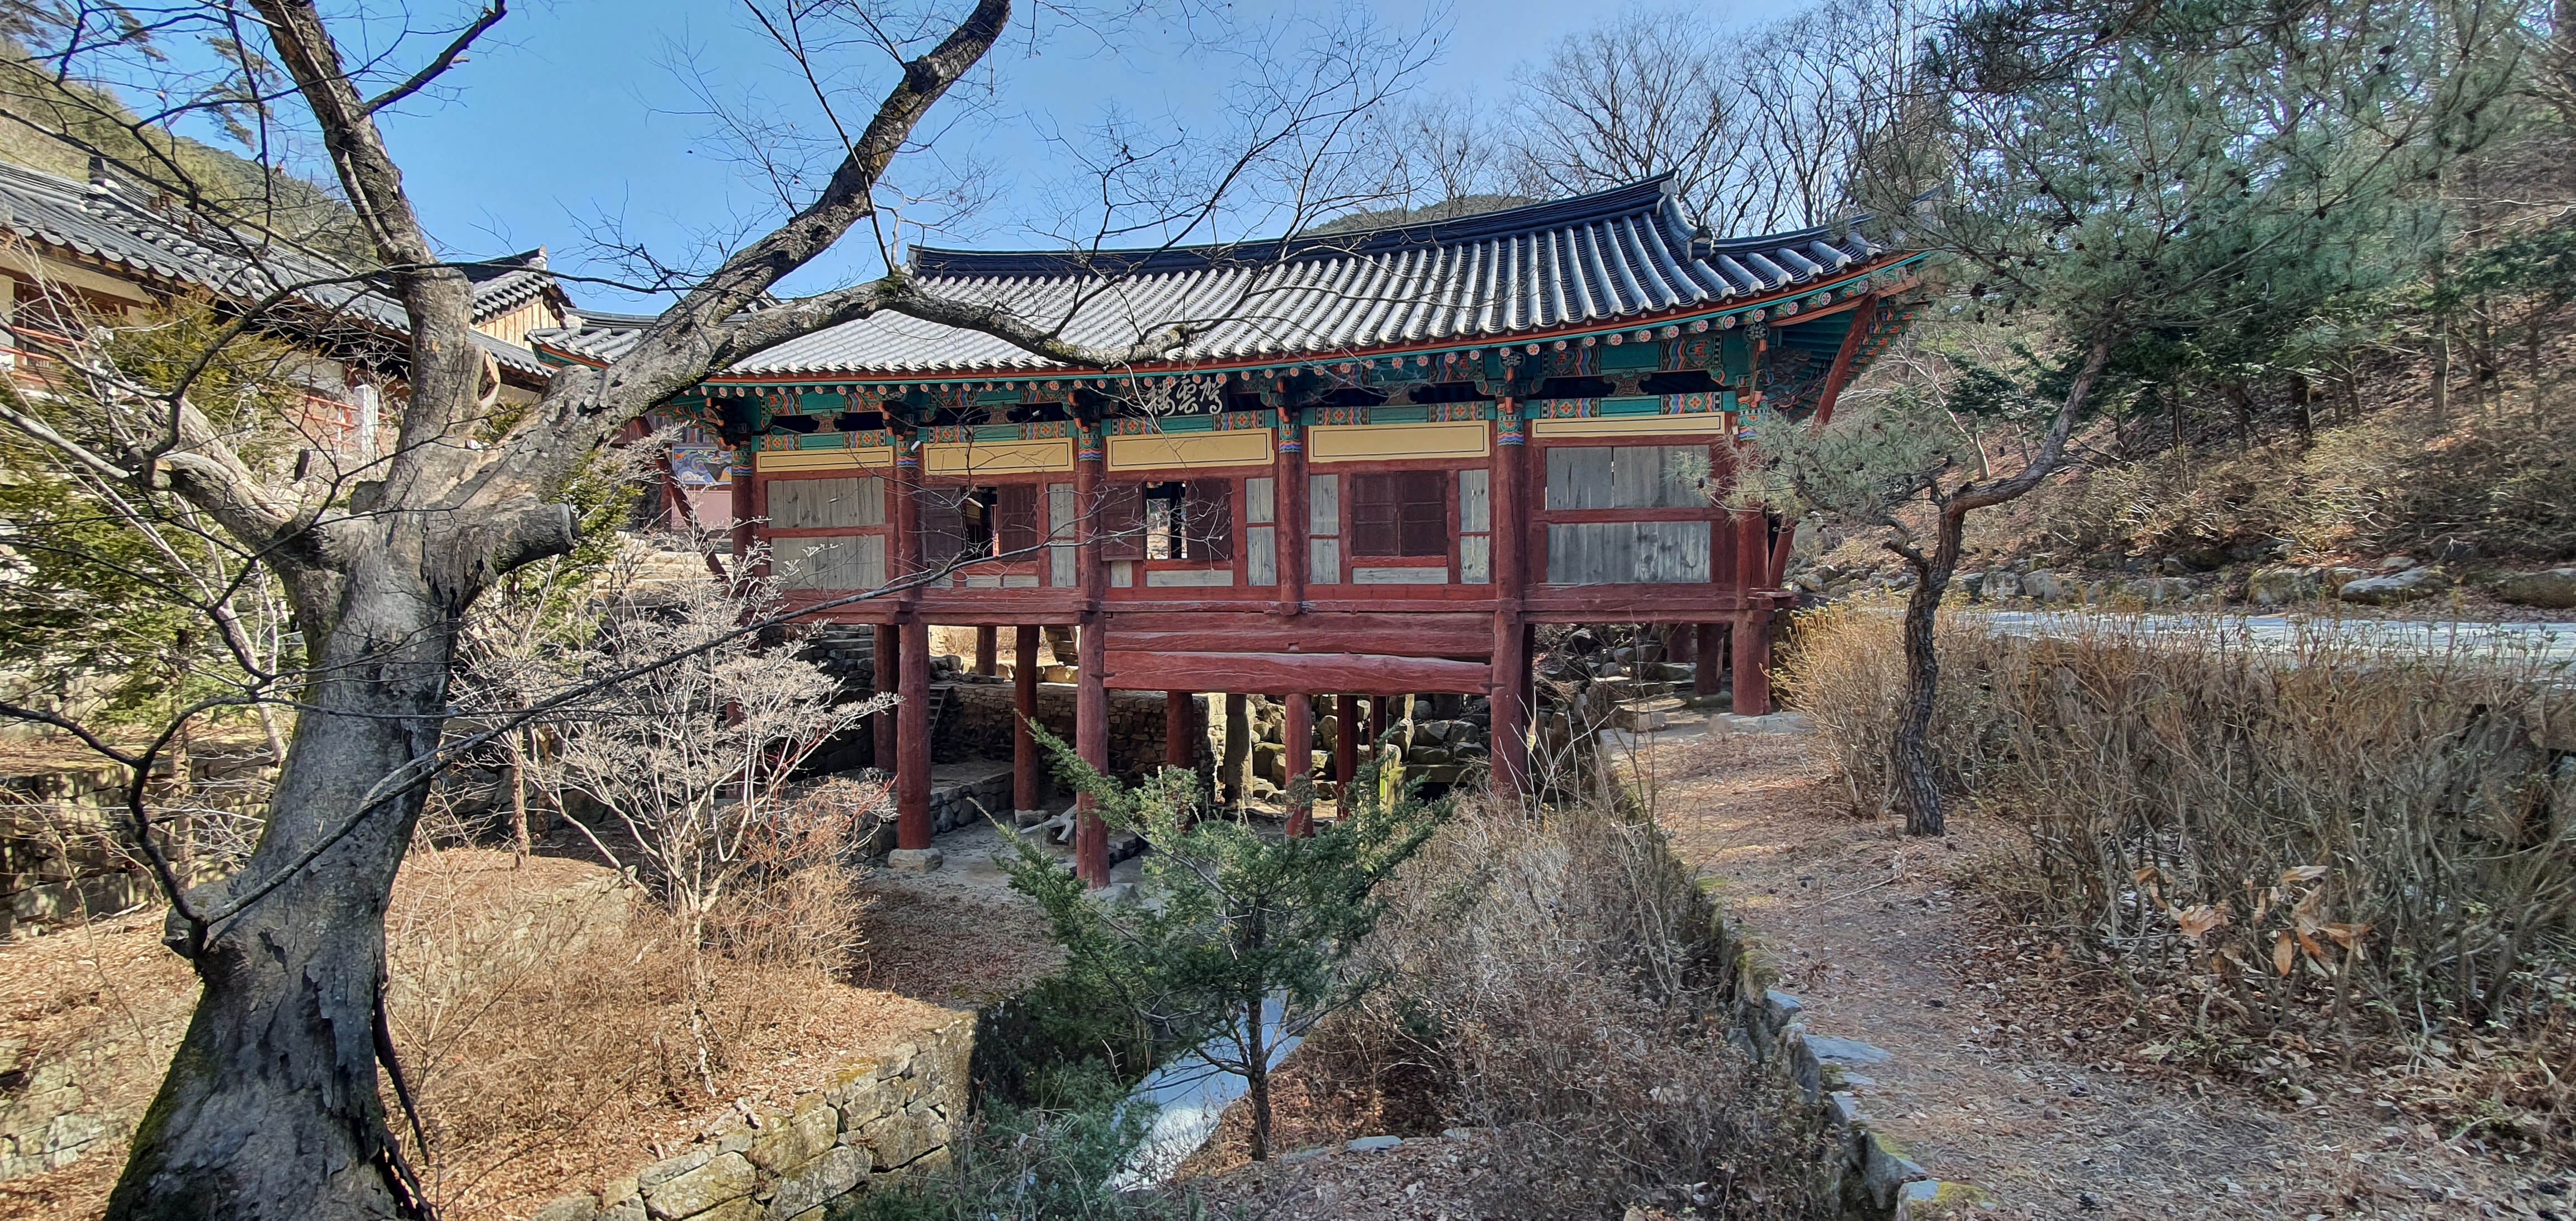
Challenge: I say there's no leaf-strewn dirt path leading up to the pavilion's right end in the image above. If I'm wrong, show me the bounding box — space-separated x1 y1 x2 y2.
1641 734 2576 1218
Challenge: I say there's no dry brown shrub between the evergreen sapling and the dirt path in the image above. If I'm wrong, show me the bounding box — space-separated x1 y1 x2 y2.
1360 801 1824 1218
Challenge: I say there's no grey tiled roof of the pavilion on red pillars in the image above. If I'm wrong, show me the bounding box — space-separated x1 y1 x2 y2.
531 178 1909 384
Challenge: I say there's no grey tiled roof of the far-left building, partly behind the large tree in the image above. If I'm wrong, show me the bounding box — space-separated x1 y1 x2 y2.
0 165 551 373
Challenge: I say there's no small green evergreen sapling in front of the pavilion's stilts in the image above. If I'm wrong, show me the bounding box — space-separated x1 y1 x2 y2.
1002 726 1450 1162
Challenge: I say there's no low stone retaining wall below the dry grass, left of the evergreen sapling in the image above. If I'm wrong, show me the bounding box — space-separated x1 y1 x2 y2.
533 1012 974 1221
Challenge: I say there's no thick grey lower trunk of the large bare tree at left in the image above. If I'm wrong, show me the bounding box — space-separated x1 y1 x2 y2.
108 561 461 1221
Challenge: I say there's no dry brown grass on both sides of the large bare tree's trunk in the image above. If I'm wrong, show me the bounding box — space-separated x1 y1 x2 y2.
0 848 956 1221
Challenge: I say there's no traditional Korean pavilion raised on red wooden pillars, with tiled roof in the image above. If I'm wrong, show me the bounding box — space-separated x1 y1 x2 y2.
533 178 1916 883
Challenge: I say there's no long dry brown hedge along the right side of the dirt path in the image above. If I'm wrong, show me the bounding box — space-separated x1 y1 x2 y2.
1788 605 2576 1128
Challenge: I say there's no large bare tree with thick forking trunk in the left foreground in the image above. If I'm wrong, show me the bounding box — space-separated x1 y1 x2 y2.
0 0 1432 1218
